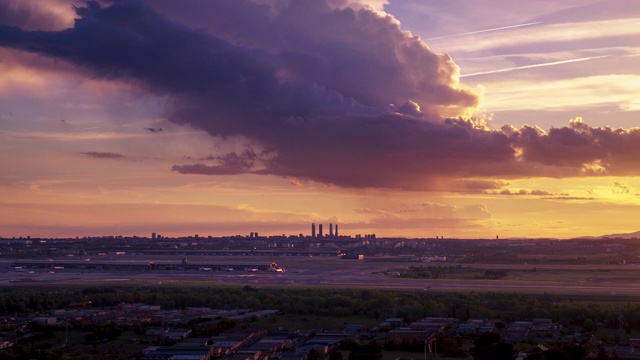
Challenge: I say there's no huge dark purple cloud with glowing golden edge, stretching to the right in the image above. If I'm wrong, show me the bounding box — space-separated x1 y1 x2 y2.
0 0 640 191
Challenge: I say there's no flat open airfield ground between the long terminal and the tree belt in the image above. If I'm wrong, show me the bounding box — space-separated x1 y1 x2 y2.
0 257 640 295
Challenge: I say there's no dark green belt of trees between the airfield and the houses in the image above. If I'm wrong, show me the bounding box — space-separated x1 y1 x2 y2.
0 286 640 328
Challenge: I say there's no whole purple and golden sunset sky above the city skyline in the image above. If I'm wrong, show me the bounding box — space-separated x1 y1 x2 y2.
0 0 640 239
